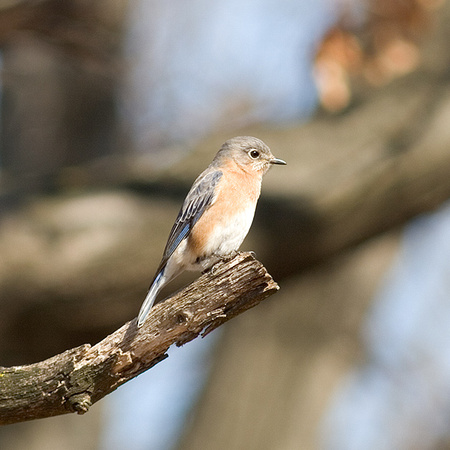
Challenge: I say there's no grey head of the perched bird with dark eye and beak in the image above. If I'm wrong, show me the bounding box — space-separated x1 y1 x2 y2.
214 136 286 175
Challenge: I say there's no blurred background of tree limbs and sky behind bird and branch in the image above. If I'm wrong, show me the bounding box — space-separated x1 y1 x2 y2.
0 0 450 450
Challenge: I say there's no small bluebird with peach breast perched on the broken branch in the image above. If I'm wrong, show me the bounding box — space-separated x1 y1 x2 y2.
137 136 286 328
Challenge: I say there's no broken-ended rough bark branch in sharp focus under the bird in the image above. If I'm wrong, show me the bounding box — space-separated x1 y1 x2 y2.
0 253 278 425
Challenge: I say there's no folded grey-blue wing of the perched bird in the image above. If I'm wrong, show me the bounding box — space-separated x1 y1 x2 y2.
156 170 222 273
